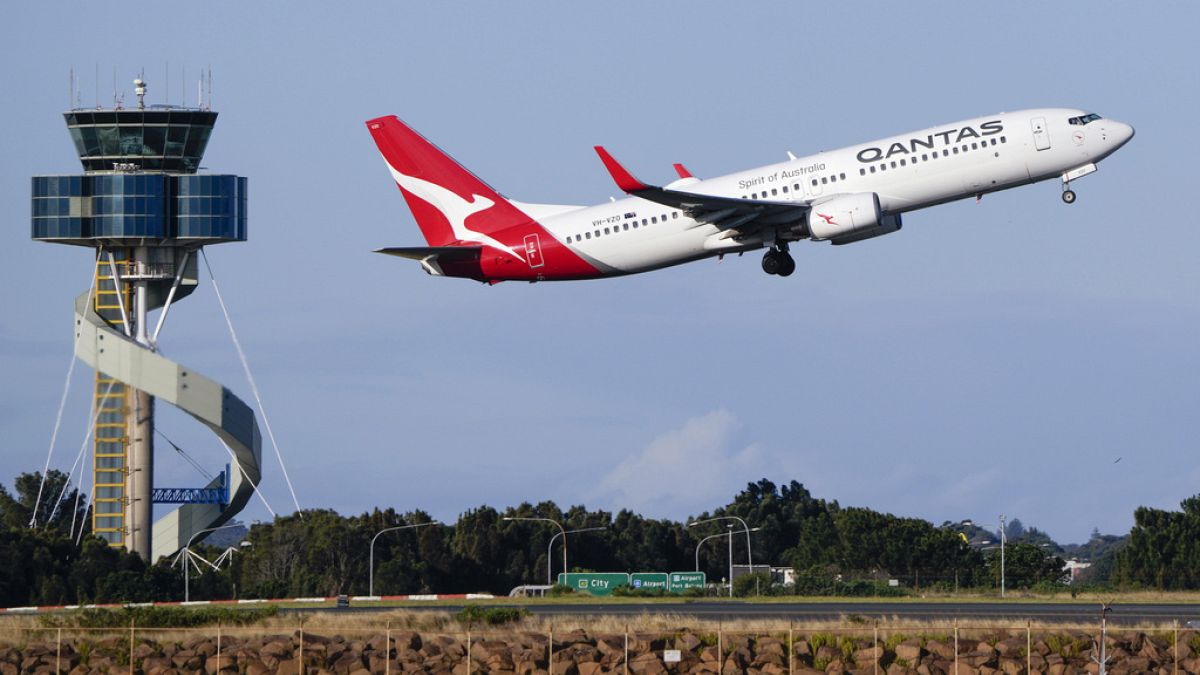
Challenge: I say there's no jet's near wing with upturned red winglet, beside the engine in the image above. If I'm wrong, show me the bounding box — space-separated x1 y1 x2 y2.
595 145 809 234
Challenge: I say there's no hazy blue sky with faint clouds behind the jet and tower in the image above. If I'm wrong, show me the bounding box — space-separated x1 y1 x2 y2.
0 2 1200 540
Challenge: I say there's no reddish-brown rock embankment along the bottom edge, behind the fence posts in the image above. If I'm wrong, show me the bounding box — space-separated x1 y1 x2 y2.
0 631 1200 675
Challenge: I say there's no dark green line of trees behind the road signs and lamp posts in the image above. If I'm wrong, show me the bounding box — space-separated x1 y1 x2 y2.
0 472 1185 607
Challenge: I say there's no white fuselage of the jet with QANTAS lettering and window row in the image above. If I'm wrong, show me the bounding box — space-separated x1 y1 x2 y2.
540 108 1133 274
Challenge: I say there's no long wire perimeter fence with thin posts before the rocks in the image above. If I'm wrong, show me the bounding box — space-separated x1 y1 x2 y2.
0 619 1200 675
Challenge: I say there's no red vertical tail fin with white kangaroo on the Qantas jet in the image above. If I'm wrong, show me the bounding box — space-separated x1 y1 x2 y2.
367 115 532 251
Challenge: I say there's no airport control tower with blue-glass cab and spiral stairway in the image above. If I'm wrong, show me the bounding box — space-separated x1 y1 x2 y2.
32 79 262 562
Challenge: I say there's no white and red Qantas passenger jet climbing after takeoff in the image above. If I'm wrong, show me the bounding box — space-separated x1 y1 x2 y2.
366 108 1134 283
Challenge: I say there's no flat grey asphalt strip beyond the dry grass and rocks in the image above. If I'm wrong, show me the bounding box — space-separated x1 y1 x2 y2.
321 602 1200 626
